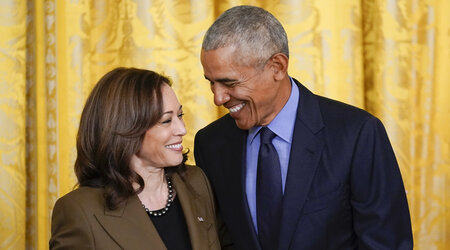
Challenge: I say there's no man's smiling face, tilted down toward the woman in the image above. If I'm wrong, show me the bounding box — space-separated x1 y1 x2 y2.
200 46 284 130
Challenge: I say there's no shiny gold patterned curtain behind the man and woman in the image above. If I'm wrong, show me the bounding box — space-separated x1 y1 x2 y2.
0 0 450 249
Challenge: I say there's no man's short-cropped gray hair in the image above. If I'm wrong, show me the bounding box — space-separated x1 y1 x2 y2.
202 5 289 67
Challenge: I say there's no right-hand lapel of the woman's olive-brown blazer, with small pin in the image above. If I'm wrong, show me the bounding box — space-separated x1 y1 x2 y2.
172 174 211 249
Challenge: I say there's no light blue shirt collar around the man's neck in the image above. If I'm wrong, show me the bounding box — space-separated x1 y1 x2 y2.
248 78 299 143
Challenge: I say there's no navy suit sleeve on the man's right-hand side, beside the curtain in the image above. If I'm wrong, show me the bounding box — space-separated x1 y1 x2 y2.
351 117 413 249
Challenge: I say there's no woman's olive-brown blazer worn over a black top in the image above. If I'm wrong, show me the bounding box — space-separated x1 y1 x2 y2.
50 167 225 250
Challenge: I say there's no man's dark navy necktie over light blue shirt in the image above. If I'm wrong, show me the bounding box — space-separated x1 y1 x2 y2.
256 127 283 250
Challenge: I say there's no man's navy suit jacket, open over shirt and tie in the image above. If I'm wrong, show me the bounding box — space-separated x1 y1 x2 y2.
194 80 413 250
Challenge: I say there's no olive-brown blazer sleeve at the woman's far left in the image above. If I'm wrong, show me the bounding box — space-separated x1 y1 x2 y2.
49 197 94 250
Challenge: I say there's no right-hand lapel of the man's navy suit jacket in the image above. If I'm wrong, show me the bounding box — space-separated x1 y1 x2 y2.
279 80 325 249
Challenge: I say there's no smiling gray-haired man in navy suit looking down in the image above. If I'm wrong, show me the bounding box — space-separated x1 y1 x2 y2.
194 6 413 250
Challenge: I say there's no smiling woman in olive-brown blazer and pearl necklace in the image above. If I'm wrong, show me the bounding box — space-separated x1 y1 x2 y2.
50 68 230 250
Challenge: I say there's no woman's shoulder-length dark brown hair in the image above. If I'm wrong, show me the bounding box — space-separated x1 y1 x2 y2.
75 68 187 209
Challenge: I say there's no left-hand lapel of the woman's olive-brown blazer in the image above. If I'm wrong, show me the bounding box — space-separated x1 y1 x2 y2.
94 195 166 250
